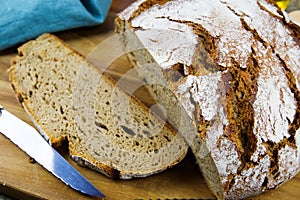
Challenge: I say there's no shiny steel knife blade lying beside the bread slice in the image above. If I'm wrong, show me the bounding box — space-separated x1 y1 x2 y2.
0 105 104 198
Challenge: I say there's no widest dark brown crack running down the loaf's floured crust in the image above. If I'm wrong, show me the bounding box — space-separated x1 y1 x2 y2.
222 50 259 191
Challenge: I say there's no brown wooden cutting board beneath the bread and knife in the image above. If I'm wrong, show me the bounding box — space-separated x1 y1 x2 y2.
0 10 300 200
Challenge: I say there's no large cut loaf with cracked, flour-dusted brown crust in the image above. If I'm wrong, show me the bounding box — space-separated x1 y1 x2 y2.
116 0 300 199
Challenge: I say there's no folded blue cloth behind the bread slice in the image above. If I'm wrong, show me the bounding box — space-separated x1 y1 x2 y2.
0 0 111 50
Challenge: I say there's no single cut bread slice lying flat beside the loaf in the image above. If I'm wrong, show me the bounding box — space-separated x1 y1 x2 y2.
10 34 187 179
